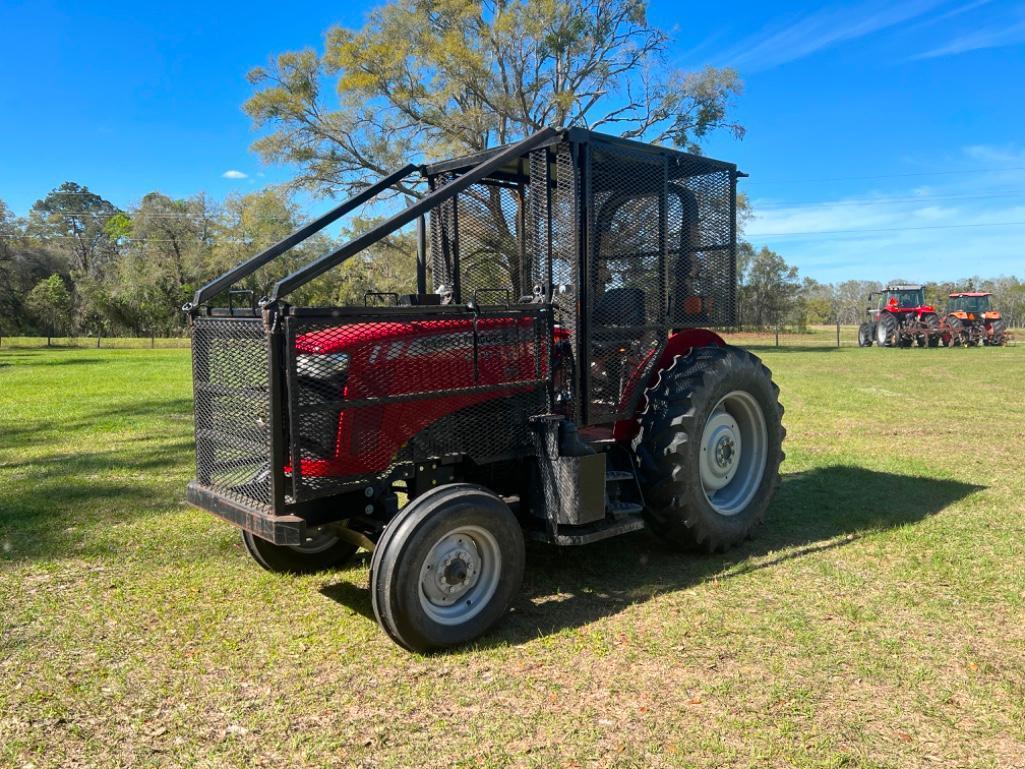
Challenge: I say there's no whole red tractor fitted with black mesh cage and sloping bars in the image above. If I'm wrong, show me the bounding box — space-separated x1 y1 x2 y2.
186 128 785 650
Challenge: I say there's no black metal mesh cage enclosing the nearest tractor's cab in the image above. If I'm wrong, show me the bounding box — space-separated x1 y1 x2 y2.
432 131 736 423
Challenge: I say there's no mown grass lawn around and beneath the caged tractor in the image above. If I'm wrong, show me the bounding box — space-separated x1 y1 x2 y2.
0 337 1025 768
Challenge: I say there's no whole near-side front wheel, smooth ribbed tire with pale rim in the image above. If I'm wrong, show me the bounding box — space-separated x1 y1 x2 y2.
370 483 526 652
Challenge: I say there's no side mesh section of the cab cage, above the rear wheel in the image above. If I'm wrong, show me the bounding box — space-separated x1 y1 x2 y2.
584 141 736 422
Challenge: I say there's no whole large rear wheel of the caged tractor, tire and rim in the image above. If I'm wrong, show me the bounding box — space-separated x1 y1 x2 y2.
633 347 786 553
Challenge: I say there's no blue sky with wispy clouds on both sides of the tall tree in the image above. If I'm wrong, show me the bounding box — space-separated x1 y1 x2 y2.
0 0 1025 281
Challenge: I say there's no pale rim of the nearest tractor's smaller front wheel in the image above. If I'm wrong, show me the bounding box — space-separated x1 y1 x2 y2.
419 526 502 624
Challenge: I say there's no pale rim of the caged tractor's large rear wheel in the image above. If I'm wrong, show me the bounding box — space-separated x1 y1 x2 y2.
698 390 769 516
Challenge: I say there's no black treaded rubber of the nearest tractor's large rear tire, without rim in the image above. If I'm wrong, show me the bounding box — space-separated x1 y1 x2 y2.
633 347 786 553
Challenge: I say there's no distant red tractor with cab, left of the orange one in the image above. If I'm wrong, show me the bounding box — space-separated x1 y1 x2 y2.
858 285 942 348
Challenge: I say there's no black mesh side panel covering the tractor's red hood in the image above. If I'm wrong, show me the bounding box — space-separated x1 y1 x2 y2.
286 309 550 501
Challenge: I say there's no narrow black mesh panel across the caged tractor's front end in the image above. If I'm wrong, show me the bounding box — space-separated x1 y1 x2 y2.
193 318 271 509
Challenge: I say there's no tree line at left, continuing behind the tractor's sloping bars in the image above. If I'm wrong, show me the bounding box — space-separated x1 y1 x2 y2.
0 181 415 336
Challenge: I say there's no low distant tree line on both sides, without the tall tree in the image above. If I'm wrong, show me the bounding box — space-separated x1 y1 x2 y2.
0 181 1025 336
